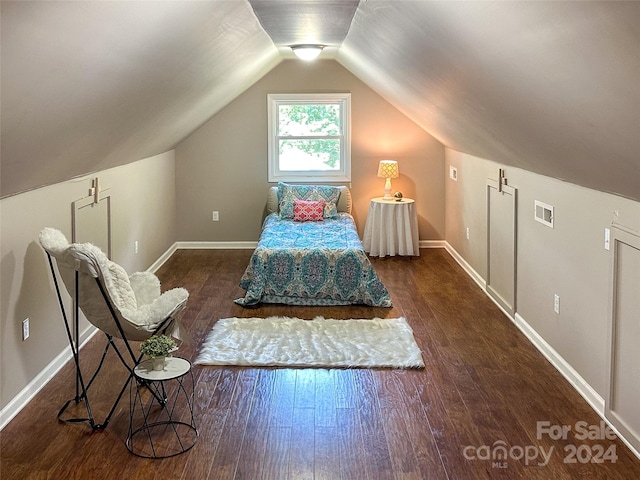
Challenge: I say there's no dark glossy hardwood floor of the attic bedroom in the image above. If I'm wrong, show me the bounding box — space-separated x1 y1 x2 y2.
0 249 640 480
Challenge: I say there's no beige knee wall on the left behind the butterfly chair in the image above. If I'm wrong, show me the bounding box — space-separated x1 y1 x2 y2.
0 151 176 414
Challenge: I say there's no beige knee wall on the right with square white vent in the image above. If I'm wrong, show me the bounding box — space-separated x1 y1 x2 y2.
446 149 640 397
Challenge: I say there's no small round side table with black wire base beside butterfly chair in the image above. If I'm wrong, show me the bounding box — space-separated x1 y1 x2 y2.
126 357 198 458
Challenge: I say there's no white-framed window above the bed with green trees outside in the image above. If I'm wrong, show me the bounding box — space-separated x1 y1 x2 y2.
267 93 351 182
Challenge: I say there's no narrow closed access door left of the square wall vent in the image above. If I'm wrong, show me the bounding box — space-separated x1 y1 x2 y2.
487 179 517 317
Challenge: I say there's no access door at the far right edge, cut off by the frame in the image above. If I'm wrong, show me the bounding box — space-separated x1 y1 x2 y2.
605 227 640 449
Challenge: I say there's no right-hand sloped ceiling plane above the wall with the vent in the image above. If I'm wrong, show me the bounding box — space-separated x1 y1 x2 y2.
338 0 640 200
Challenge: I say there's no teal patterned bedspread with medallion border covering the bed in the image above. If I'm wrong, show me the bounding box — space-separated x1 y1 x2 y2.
235 213 392 307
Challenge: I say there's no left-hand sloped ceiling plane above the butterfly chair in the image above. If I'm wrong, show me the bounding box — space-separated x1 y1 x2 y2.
0 1 281 196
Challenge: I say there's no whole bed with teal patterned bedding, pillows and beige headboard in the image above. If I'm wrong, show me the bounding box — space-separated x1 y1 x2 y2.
235 183 392 307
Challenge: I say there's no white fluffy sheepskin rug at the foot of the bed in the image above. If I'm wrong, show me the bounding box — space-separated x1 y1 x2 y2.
195 317 424 368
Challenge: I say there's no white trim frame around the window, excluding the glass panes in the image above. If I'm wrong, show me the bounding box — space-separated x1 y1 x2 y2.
267 93 351 183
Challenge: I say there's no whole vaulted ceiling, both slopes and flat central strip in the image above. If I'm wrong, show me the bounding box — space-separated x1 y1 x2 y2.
0 0 640 200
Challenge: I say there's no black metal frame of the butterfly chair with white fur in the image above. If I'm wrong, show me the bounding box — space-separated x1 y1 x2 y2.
47 252 173 430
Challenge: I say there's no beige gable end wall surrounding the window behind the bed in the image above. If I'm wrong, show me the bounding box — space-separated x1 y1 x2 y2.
176 60 444 241
